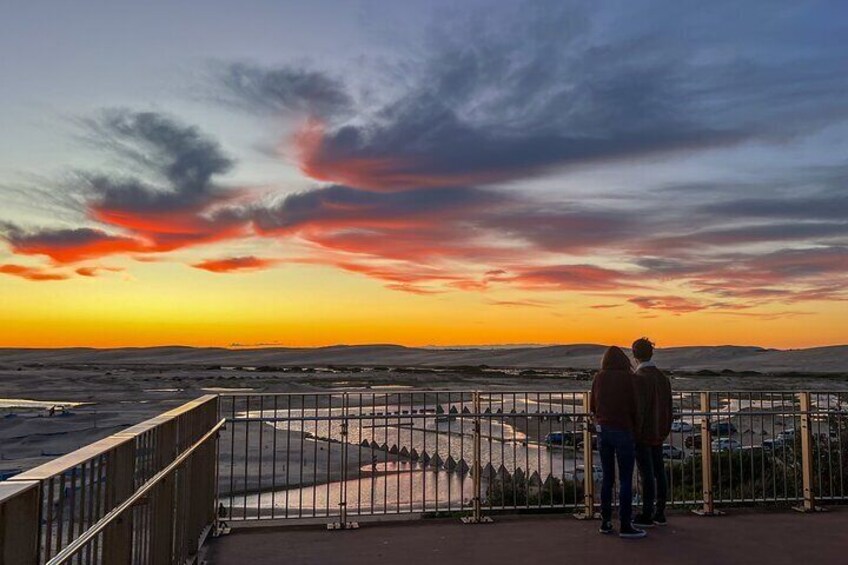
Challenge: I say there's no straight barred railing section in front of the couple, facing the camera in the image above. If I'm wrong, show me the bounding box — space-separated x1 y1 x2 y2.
218 390 848 525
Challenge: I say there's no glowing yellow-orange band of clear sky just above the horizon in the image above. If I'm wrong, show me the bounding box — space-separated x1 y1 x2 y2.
0 263 848 347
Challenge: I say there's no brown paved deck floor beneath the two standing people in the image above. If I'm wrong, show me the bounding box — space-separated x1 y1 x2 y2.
208 509 848 565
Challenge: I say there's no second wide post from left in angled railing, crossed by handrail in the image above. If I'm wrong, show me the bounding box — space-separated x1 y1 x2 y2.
103 441 135 565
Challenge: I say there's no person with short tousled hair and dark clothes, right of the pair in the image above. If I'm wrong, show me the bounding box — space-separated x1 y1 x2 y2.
632 337 672 528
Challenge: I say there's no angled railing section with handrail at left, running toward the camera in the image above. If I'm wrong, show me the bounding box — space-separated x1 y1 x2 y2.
0 395 224 565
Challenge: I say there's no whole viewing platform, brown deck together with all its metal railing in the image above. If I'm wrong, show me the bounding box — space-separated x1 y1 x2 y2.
0 390 848 565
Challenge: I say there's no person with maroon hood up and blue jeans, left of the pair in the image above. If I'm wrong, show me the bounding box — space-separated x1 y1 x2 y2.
586 347 645 538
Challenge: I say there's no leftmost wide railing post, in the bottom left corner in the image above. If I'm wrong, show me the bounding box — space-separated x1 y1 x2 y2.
0 481 39 565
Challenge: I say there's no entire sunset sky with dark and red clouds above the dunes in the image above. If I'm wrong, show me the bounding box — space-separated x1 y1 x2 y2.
0 0 848 348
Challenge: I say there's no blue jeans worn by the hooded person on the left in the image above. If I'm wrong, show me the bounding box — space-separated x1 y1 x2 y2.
599 426 636 526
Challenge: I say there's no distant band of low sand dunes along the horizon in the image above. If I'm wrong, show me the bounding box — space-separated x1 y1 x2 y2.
0 344 848 373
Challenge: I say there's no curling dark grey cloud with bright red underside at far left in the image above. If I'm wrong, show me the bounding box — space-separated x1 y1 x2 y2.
4 110 252 263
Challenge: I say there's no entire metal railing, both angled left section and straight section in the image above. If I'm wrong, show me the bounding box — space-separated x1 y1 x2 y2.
0 390 848 565
